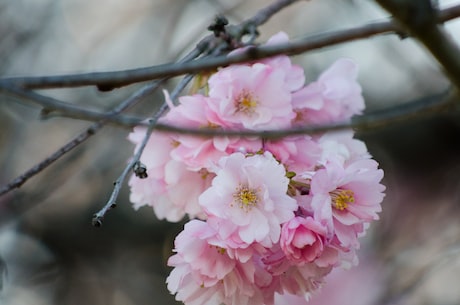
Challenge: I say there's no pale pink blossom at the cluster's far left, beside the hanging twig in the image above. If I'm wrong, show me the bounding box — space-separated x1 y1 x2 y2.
129 127 214 222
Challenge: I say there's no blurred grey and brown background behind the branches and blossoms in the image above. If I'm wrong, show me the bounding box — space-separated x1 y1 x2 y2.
0 0 460 305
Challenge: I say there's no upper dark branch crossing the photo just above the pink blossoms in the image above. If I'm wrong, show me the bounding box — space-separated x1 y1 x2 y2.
0 5 460 89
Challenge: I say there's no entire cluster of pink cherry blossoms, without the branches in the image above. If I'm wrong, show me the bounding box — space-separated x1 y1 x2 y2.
129 33 385 305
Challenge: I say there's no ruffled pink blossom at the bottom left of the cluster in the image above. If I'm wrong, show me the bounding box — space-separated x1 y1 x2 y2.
167 220 271 305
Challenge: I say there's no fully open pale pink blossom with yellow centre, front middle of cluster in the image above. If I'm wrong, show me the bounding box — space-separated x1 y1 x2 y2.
199 152 297 247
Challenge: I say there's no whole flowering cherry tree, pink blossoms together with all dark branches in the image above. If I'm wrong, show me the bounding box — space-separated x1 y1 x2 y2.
0 0 460 305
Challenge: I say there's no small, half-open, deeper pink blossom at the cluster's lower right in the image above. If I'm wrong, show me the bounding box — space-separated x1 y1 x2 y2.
280 217 327 265
